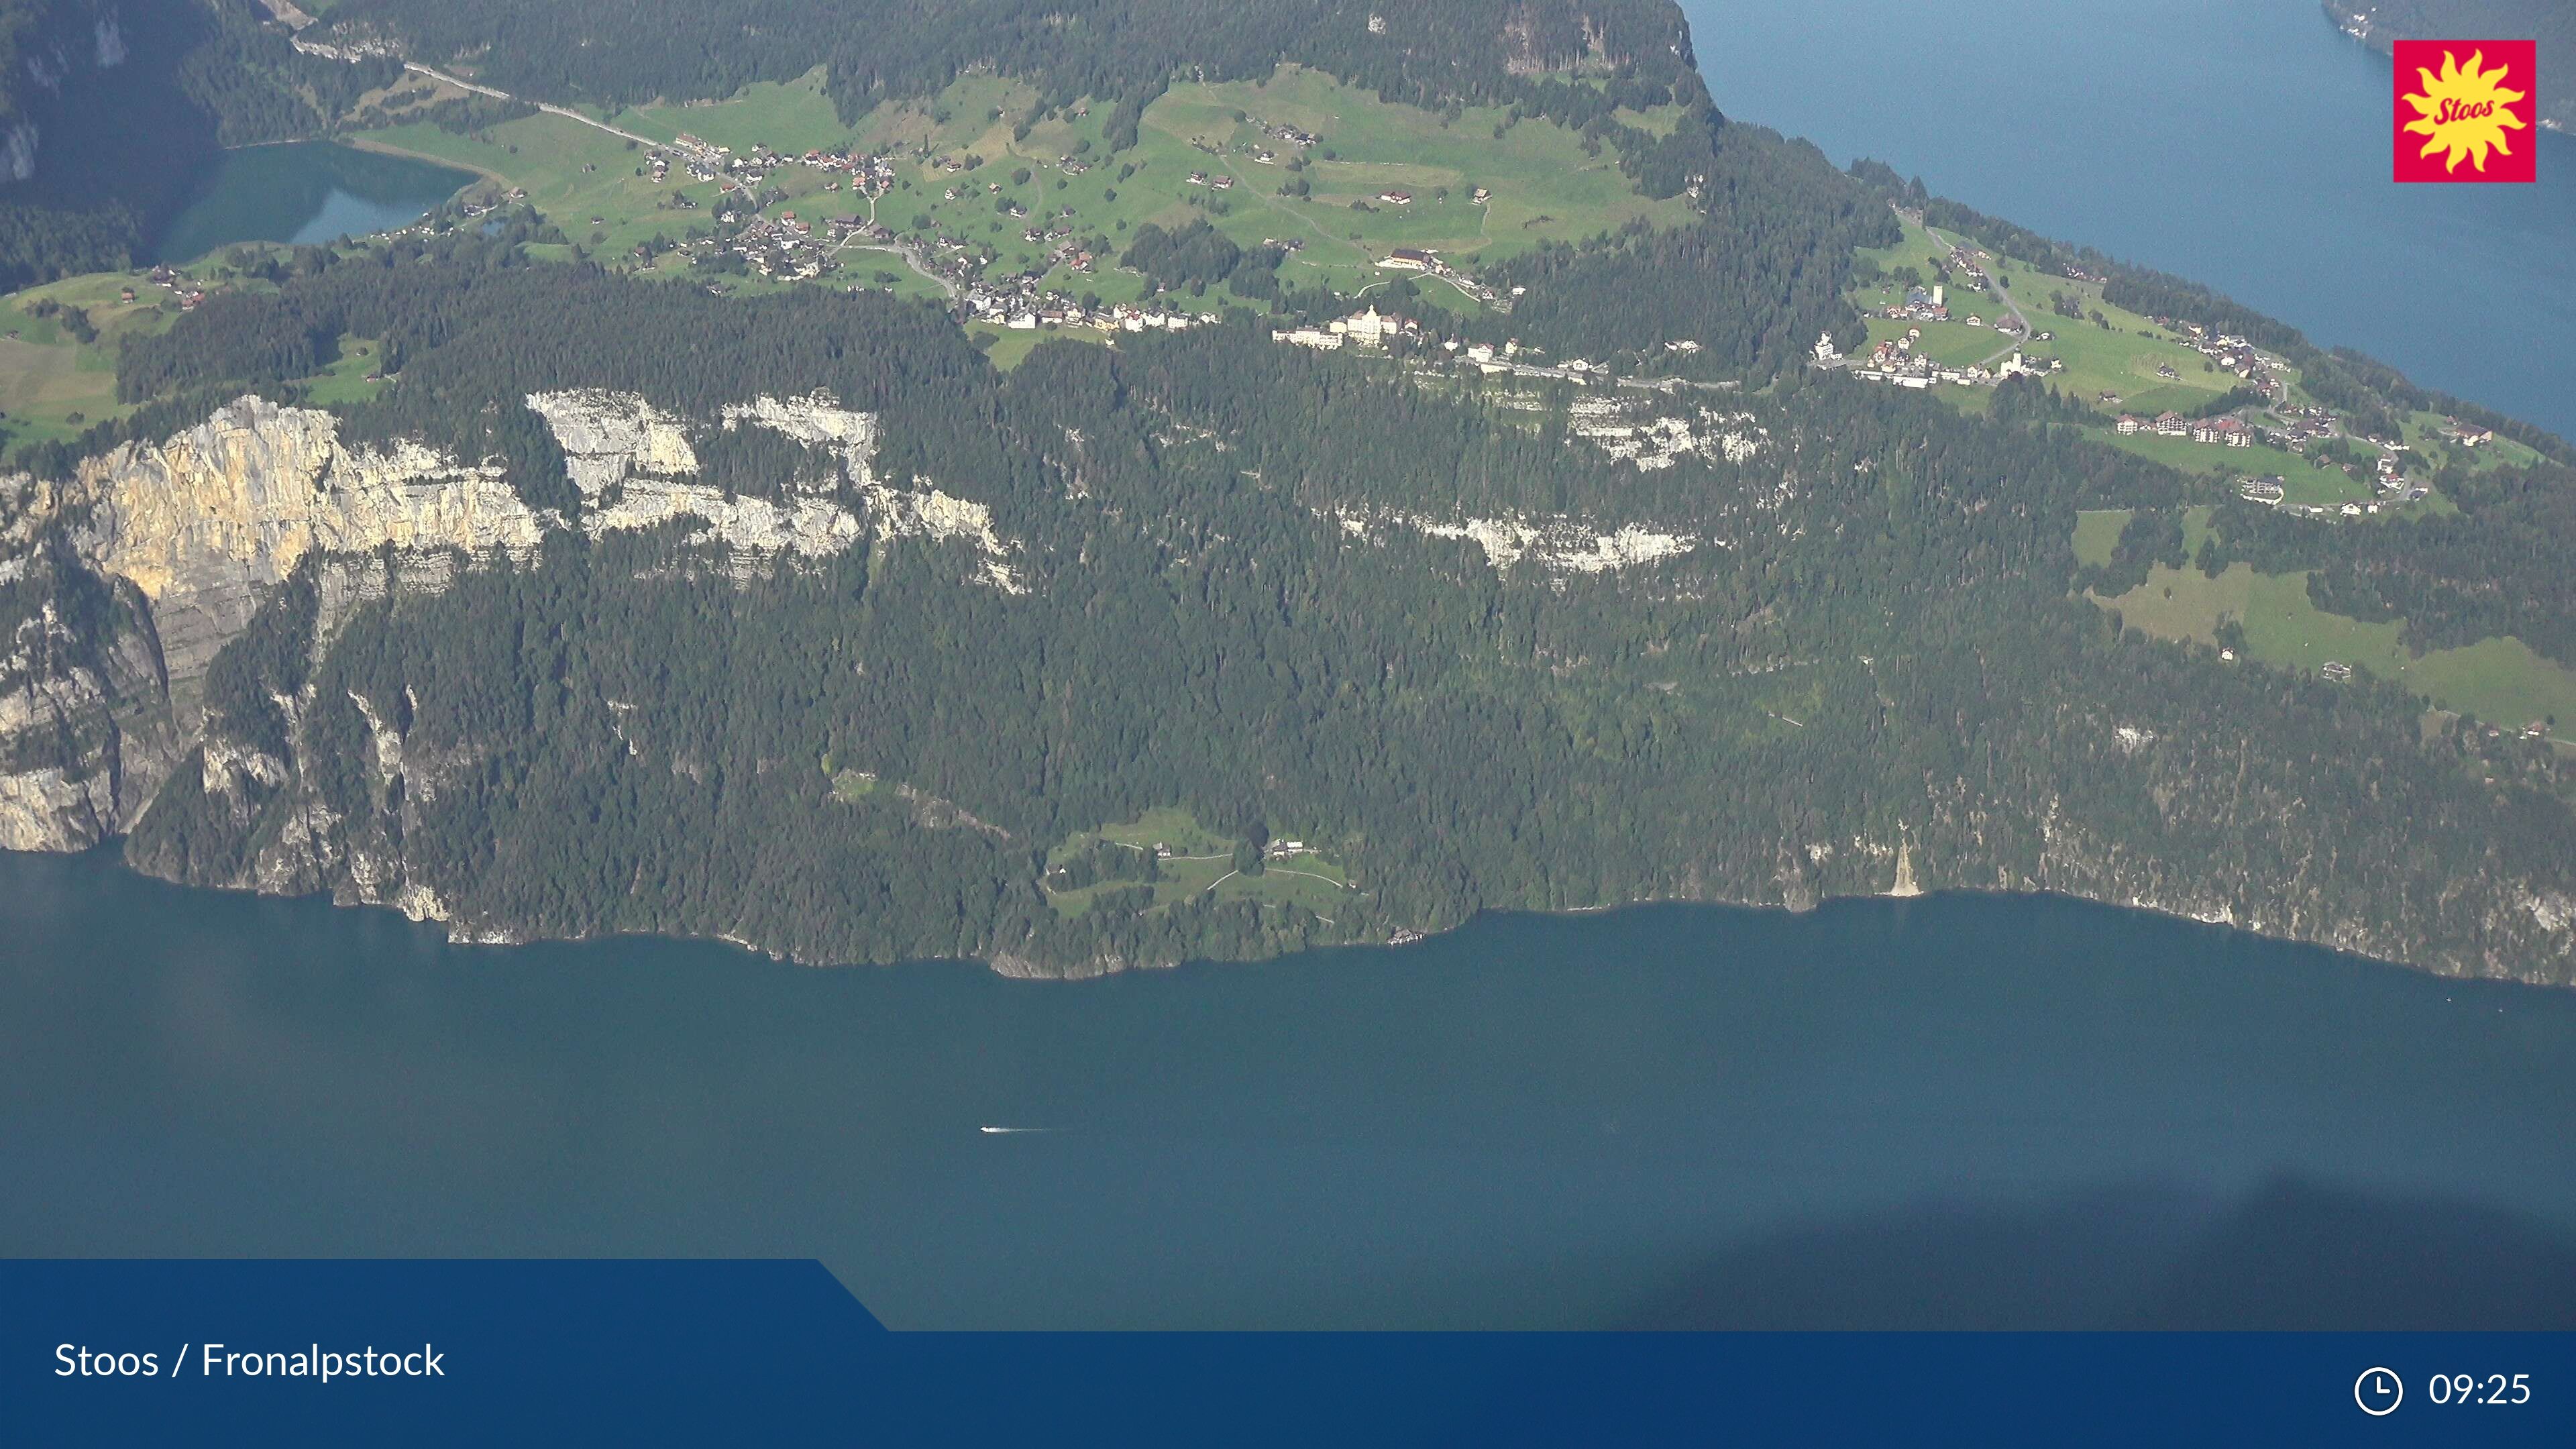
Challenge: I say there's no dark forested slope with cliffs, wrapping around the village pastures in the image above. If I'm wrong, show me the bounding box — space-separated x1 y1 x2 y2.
0 0 2576 982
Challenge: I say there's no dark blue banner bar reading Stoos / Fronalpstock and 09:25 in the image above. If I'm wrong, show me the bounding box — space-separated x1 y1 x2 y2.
0 1260 2576 1446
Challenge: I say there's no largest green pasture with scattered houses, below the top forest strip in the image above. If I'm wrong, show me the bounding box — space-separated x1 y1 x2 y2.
358 67 1690 312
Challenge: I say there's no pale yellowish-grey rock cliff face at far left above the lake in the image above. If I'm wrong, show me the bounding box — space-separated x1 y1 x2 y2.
0 392 1020 856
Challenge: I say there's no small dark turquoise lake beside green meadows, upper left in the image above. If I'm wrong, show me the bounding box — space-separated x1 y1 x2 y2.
157 142 474 263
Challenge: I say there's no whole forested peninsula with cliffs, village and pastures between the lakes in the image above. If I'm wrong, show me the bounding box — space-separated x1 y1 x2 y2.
0 0 2576 985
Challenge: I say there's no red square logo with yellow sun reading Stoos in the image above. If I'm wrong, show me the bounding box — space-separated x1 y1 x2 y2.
2393 41 2540 180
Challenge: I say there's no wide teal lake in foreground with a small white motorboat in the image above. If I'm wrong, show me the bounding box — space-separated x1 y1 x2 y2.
0 853 2576 1328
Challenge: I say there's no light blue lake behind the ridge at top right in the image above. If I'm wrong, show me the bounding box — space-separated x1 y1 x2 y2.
1682 0 2576 436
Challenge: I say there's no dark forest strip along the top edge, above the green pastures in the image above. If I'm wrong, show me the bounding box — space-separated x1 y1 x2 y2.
330 0 1698 119
